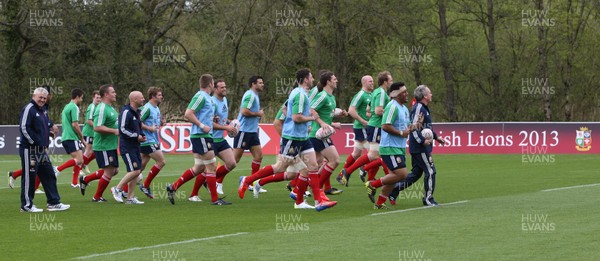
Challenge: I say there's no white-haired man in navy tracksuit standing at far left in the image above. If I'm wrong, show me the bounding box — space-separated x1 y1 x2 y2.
19 87 70 212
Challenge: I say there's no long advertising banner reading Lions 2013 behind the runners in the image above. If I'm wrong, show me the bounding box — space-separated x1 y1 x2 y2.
0 122 600 155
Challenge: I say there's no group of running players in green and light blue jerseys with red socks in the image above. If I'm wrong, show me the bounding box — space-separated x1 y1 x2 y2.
9 69 437 211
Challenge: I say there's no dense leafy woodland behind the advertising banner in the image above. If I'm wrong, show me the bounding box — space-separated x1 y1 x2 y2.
0 0 600 124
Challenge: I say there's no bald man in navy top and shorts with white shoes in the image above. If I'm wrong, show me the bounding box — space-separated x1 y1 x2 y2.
110 91 146 204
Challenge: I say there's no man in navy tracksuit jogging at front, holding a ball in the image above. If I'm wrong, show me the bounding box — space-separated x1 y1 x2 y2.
390 85 445 206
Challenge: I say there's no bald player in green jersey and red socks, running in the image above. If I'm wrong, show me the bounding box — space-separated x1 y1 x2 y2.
336 75 374 183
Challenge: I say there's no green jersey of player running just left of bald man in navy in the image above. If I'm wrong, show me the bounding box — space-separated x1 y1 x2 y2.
92 102 119 151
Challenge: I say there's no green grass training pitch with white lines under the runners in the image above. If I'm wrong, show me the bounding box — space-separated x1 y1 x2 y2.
0 155 600 261
